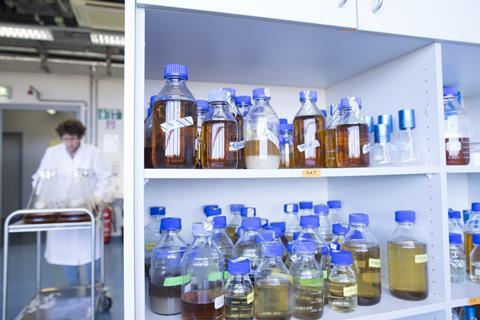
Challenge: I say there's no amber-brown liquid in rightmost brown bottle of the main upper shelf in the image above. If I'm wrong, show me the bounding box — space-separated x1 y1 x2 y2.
336 123 370 168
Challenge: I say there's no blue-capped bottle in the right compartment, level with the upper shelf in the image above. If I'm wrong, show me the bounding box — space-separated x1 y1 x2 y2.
443 87 470 165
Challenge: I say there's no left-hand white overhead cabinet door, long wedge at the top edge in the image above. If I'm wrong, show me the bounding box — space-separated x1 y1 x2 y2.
137 0 357 29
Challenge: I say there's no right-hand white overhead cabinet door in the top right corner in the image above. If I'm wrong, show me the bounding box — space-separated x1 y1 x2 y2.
358 0 480 43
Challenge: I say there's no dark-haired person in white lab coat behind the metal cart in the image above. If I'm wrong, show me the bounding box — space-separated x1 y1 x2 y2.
33 119 112 286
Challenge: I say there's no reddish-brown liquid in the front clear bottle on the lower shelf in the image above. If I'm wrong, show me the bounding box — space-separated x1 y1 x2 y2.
182 290 224 320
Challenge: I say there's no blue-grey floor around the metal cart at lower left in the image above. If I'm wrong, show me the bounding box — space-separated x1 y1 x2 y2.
0 234 123 320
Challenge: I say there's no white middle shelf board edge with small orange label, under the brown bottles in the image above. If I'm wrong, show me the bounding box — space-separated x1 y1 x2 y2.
144 166 440 179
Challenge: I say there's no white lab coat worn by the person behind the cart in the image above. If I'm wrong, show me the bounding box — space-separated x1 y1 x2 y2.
33 143 111 266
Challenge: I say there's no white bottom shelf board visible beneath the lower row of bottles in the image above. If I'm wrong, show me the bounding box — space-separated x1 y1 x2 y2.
145 288 445 320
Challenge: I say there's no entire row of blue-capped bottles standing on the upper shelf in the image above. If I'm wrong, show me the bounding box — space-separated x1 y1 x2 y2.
144 64 420 169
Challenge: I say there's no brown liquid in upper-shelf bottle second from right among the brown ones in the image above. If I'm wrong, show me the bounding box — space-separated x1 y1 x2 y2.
293 115 325 168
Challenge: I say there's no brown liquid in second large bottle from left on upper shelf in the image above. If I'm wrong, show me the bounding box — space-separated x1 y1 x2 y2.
201 120 238 169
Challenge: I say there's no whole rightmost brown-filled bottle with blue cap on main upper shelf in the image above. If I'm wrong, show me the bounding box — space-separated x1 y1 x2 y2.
336 97 370 168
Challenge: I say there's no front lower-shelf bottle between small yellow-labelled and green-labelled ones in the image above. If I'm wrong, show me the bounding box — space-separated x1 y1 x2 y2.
255 243 293 320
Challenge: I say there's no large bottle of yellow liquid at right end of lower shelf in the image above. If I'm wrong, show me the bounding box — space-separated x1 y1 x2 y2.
387 210 428 300
